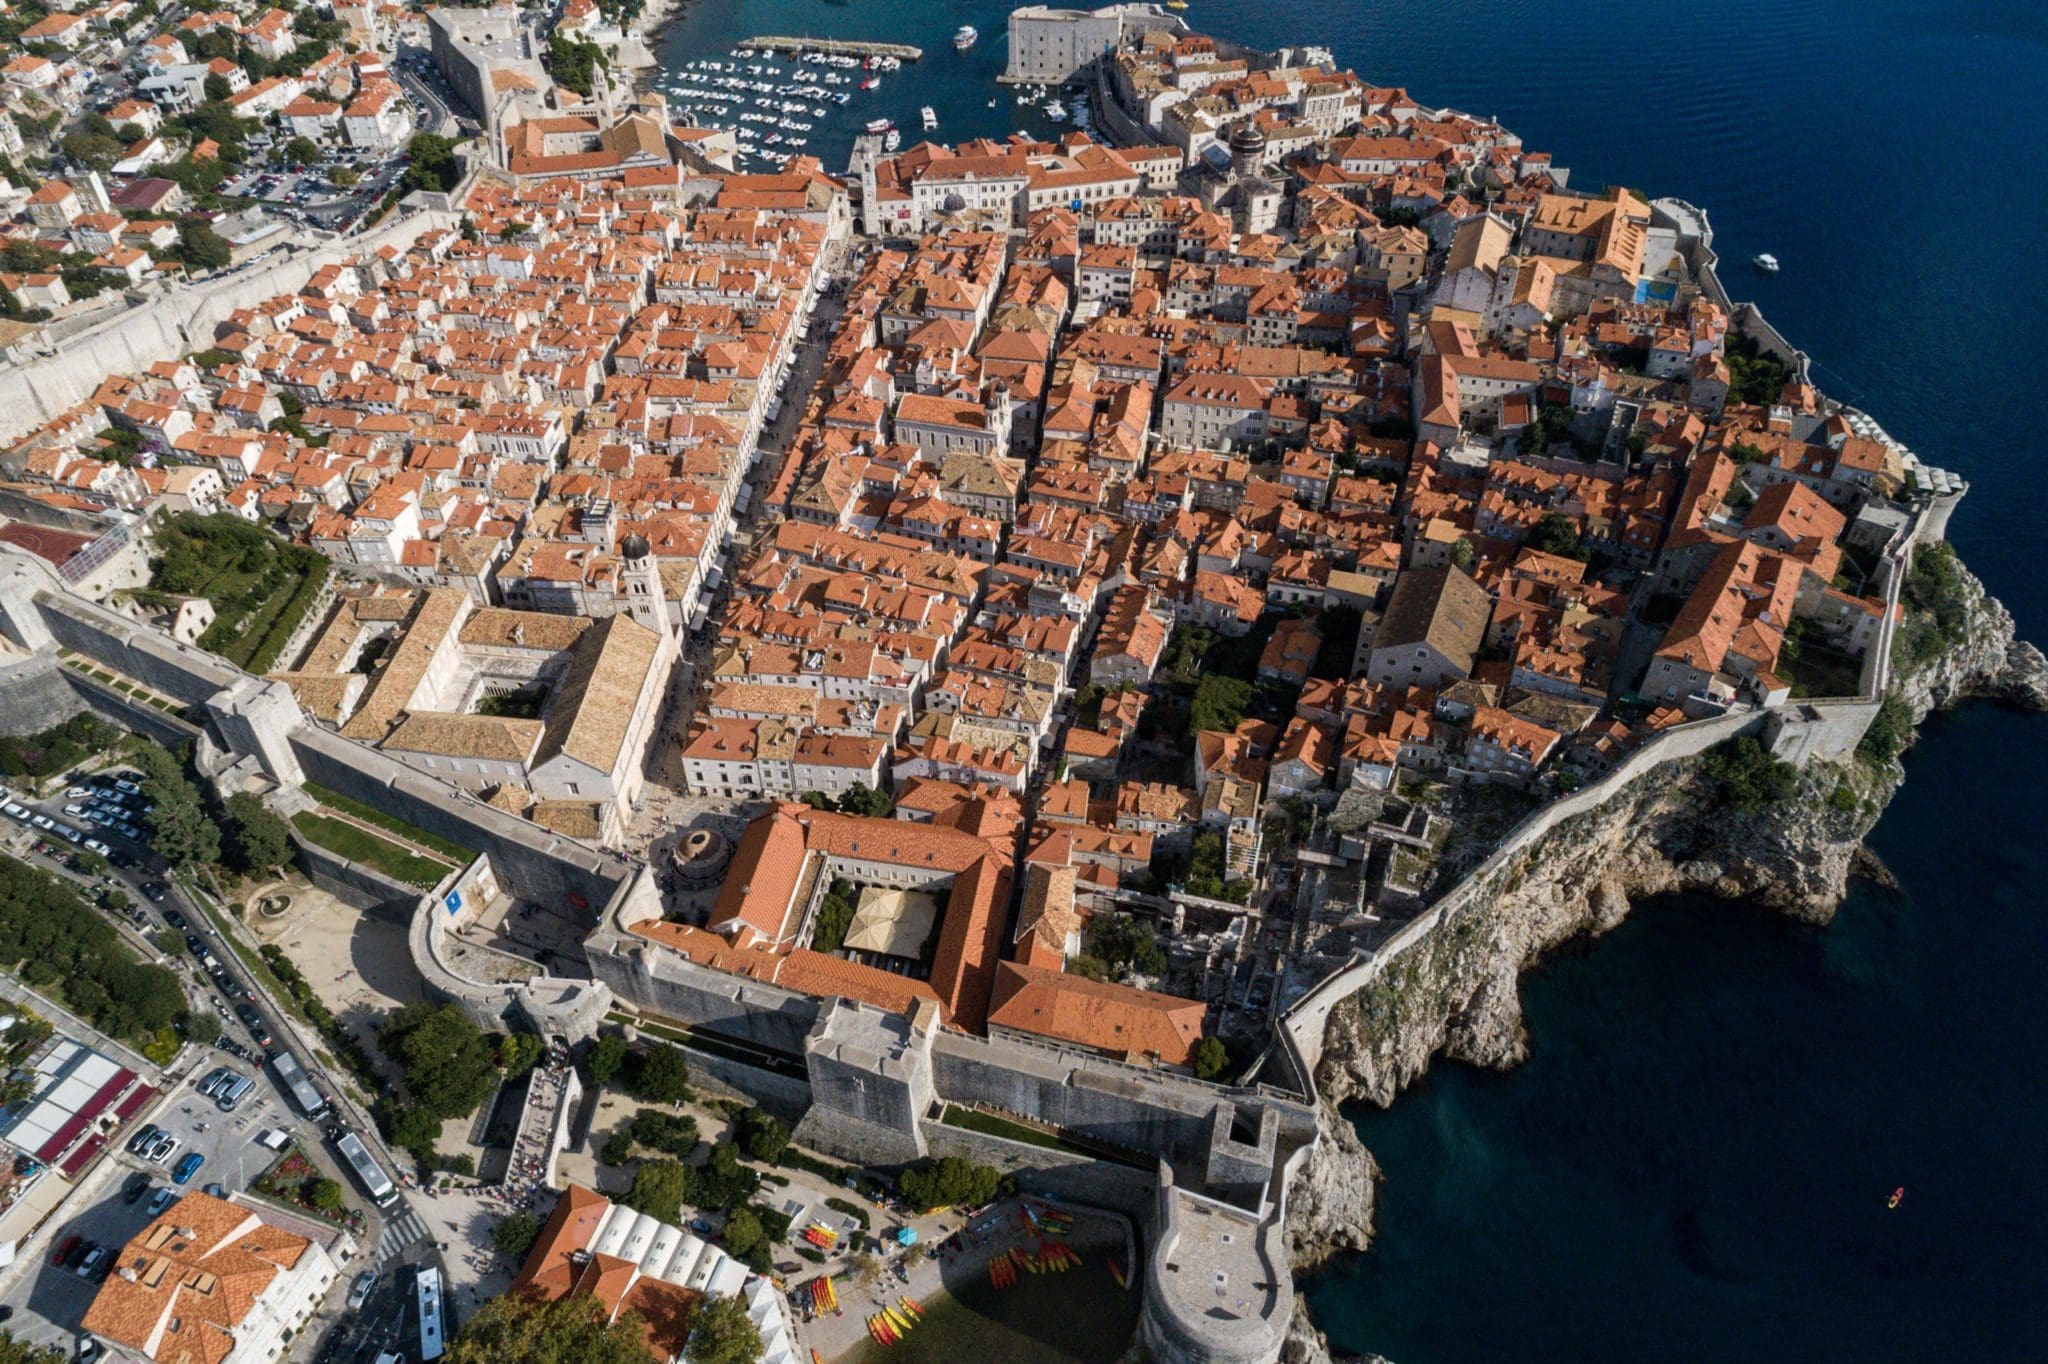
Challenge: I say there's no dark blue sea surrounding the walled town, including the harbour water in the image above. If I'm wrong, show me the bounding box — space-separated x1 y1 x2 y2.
664 0 2048 1364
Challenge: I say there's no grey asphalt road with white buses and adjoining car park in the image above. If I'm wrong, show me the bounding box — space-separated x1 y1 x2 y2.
0 770 440 1360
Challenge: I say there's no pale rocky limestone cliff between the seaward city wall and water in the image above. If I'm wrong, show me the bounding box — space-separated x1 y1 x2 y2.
1288 547 2048 1335
